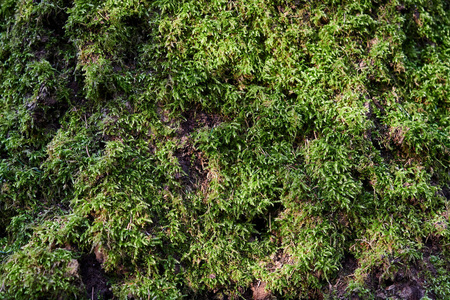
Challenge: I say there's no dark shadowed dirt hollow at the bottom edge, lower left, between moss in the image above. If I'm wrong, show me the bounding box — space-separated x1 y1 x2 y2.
79 254 113 300
